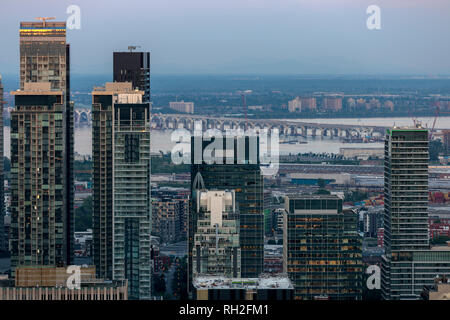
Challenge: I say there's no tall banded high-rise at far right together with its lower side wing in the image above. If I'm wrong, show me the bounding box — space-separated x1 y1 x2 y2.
381 124 450 300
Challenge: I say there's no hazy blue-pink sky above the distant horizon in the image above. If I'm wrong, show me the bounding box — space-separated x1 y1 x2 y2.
0 0 450 75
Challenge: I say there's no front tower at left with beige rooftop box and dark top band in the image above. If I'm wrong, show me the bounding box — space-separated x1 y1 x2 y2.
10 82 72 272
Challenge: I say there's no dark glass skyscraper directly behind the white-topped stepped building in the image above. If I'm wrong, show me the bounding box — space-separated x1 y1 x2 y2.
188 136 264 292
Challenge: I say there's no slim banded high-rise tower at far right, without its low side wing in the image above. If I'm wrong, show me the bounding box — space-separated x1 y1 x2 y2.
382 128 429 299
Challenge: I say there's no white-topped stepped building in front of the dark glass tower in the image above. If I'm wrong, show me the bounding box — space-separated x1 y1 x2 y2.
192 190 241 278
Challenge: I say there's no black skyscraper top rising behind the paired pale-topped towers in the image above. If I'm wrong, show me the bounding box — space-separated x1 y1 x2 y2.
113 52 150 102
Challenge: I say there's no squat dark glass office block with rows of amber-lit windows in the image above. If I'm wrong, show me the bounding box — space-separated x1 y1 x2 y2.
283 195 363 300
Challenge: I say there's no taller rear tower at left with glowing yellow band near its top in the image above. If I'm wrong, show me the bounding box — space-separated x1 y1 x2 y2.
17 20 75 264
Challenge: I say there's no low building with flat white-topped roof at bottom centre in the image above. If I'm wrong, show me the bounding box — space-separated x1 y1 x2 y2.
194 274 294 301
